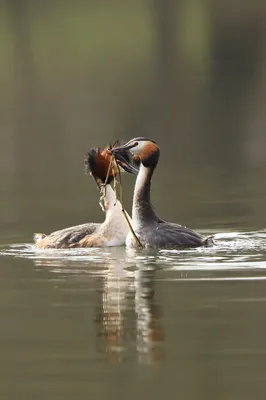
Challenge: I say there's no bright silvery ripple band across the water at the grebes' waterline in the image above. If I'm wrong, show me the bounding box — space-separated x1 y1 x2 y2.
0 231 266 275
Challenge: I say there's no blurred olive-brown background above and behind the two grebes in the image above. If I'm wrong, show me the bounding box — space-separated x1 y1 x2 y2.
0 0 266 243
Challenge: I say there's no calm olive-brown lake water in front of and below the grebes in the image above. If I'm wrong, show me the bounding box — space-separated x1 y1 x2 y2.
0 231 266 400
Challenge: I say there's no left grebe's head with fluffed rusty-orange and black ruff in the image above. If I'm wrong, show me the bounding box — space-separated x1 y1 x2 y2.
84 142 137 186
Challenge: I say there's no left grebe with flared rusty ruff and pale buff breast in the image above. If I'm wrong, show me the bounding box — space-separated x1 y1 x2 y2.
34 144 136 249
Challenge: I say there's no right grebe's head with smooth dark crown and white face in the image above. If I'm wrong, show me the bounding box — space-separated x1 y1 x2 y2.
111 137 160 168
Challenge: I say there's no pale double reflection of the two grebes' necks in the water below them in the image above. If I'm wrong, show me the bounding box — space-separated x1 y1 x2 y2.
97 265 164 363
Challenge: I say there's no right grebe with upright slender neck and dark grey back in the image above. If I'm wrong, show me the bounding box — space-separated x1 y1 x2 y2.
111 137 212 249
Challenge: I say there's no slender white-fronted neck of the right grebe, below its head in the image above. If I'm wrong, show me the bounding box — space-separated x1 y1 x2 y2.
132 163 158 225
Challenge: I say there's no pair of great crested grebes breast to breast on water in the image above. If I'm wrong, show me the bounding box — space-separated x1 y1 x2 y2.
34 137 213 249
